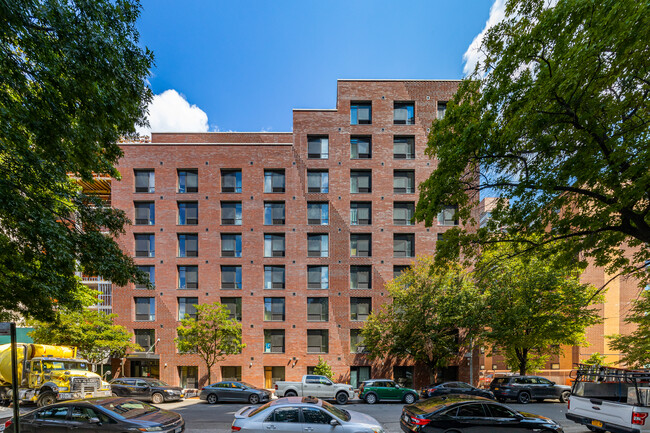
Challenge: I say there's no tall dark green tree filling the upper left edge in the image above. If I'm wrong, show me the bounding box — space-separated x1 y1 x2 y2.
0 0 153 320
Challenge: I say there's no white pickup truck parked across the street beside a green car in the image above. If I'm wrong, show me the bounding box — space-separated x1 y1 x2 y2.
275 374 354 404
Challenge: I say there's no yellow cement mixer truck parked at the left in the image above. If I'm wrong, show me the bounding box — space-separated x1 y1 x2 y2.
0 343 111 407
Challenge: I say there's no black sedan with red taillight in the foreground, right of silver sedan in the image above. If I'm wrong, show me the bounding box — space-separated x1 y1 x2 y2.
400 394 563 433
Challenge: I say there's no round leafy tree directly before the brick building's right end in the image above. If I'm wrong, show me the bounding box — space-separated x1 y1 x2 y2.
362 257 482 375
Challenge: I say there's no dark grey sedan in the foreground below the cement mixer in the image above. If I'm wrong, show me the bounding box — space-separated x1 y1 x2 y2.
5 397 185 433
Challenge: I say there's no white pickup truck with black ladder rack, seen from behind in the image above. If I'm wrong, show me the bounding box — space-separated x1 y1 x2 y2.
566 365 650 433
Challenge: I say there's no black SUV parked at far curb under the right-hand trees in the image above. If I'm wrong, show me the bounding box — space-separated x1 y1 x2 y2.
490 376 571 404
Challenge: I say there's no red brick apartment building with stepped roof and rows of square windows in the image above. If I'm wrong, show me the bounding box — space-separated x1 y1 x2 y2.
111 80 464 387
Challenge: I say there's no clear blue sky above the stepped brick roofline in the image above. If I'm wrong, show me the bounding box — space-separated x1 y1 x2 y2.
138 0 502 131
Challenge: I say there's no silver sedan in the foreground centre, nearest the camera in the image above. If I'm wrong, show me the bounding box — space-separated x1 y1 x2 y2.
231 397 384 433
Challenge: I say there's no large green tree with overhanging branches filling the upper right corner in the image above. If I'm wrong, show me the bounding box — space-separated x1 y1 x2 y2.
416 0 650 286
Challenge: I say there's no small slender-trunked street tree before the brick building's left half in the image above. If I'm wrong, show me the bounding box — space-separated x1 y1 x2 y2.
175 302 246 383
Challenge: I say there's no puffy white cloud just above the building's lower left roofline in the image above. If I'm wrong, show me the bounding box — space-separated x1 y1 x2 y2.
136 89 210 135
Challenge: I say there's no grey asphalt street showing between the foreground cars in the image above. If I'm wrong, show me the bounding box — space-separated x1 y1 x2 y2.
158 398 589 433
